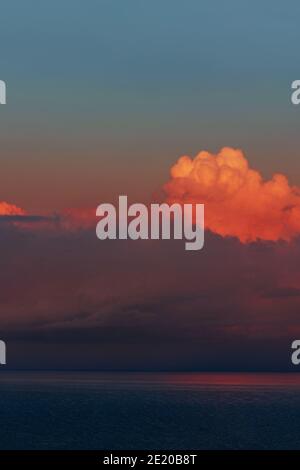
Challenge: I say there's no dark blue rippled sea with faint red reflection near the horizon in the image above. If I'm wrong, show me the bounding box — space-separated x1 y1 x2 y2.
0 371 300 450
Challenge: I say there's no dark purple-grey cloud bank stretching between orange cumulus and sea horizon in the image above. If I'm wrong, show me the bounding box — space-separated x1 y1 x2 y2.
0 224 300 371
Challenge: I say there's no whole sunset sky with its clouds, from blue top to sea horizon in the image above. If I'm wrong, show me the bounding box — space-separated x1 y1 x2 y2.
0 0 300 370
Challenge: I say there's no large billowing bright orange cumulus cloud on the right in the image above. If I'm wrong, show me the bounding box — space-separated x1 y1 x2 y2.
164 147 300 243
